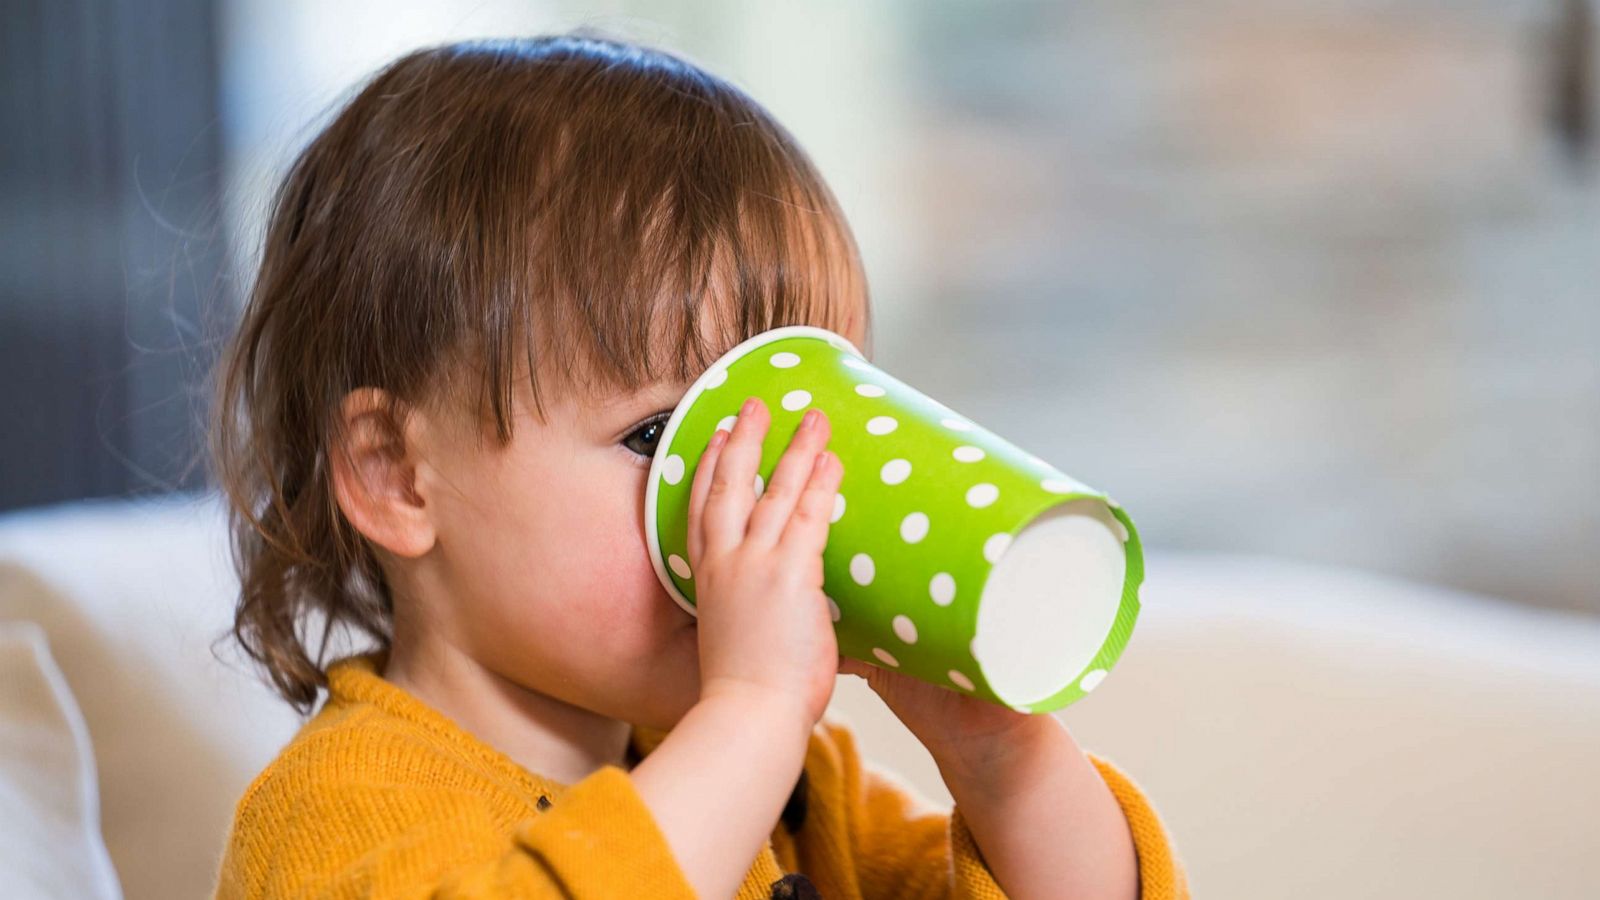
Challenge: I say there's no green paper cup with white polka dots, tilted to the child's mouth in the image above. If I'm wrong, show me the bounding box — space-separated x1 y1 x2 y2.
645 325 1144 713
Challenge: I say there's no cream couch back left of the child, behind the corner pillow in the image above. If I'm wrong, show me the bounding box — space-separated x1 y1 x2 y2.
0 495 299 900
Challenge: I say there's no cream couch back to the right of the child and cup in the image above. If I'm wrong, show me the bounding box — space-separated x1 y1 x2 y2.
1030 551 1600 900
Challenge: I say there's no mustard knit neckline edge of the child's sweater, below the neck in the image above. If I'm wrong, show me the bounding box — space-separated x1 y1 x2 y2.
328 649 667 790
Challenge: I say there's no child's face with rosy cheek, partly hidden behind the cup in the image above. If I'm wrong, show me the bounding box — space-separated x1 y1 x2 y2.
406 318 861 729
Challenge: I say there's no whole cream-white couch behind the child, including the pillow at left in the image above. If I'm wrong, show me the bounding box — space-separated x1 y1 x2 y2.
0 495 1600 900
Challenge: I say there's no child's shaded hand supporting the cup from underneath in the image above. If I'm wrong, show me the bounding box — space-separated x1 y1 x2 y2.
838 646 1054 772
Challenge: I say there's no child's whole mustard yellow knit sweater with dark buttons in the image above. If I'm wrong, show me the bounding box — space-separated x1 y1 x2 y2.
216 652 1189 900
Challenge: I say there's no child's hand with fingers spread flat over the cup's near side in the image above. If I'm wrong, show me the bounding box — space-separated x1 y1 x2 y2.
688 397 843 729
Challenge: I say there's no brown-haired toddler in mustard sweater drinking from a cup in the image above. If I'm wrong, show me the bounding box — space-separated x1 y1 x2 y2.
211 27 1187 900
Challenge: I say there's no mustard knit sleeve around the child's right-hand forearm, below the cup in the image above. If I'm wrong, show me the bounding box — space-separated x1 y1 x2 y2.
822 719 1189 900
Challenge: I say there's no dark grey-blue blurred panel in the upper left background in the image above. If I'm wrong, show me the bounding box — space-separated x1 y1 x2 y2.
0 0 227 509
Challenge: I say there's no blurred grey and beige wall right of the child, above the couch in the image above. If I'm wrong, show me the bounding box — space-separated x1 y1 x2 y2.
880 0 1600 612
